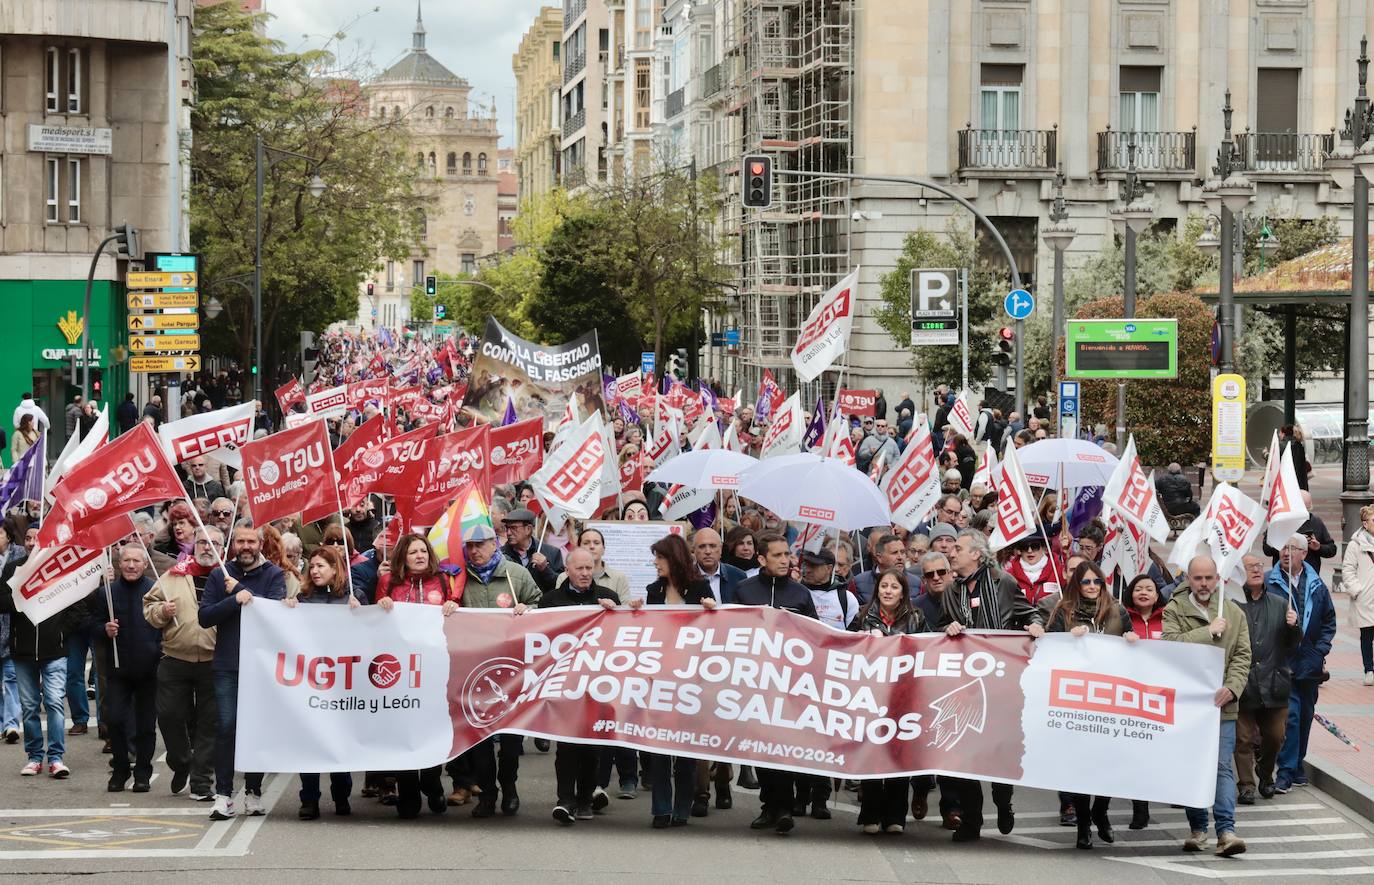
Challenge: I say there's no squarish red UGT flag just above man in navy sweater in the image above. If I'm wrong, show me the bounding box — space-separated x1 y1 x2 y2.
240 421 338 525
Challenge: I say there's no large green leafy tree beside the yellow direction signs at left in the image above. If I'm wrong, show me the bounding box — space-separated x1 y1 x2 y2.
191 3 418 385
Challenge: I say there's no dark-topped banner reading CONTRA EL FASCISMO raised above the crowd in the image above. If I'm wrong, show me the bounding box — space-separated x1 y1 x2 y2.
464 317 606 425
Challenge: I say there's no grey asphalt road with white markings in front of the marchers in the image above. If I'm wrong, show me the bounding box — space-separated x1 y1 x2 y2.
0 726 1374 885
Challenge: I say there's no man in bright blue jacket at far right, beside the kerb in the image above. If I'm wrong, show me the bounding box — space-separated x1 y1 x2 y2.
1264 533 1336 793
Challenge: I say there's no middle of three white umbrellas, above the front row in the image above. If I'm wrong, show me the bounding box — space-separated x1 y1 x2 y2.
739 452 892 532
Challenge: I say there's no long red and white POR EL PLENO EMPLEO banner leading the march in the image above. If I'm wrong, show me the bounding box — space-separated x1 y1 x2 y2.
236 603 1223 807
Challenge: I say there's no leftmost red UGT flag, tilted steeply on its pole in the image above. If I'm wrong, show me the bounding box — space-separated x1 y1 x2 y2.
38 423 185 547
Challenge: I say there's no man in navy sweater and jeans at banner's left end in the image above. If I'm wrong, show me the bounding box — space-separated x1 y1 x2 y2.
198 521 286 820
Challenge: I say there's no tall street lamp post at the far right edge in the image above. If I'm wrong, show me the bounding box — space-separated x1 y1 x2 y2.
1341 37 1374 543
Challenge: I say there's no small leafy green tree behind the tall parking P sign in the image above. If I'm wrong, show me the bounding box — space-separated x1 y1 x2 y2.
874 221 1009 386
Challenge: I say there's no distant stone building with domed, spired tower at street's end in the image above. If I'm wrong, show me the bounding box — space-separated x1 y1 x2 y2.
357 5 500 328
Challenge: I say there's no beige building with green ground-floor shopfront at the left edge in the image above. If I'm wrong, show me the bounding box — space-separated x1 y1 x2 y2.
0 0 194 464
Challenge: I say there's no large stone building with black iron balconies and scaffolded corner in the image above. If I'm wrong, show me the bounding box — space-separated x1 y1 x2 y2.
692 0 1374 404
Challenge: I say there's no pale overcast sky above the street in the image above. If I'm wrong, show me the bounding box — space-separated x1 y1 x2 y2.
264 0 549 147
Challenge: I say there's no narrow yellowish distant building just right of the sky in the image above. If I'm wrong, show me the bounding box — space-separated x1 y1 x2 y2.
511 5 563 199
